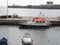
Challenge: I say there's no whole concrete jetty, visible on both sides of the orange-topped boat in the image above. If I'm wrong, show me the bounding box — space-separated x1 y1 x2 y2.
0 17 60 26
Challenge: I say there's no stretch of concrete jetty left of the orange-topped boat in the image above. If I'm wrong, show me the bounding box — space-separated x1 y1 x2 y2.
0 17 31 25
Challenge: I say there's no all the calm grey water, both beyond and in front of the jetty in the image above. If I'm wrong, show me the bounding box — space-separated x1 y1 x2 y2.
0 7 60 45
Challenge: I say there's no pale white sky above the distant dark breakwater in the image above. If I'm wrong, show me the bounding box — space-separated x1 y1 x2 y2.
0 0 60 6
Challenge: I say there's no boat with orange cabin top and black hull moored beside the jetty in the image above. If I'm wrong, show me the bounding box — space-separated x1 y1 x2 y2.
19 17 49 28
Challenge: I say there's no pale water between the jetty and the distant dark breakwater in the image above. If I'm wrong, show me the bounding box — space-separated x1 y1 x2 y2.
0 6 60 17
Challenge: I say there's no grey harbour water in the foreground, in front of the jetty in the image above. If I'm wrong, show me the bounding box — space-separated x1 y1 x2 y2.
0 25 60 45
